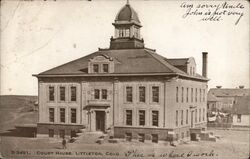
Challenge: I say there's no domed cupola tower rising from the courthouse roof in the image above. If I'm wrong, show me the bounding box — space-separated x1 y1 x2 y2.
110 1 144 49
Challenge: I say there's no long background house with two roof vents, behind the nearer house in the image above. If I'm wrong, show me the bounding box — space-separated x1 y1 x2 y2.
208 86 249 113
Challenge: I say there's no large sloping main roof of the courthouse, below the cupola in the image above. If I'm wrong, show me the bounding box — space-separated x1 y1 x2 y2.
38 48 207 80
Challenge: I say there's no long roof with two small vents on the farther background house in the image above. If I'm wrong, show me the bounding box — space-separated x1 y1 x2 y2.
209 88 249 97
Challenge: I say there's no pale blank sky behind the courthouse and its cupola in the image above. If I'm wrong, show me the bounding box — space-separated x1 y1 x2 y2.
0 0 249 95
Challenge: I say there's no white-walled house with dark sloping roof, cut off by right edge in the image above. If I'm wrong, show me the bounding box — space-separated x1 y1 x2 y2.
233 96 250 127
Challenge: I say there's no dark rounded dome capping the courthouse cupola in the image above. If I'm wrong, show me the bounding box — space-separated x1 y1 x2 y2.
115 4 140 23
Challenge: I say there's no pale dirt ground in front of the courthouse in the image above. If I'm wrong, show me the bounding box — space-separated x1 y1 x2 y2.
1 130 249 159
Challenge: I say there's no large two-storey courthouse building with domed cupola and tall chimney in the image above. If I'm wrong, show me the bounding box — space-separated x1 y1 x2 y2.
35 1 208 141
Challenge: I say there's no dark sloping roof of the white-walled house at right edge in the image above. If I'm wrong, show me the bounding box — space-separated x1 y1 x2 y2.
233 96 250 115
